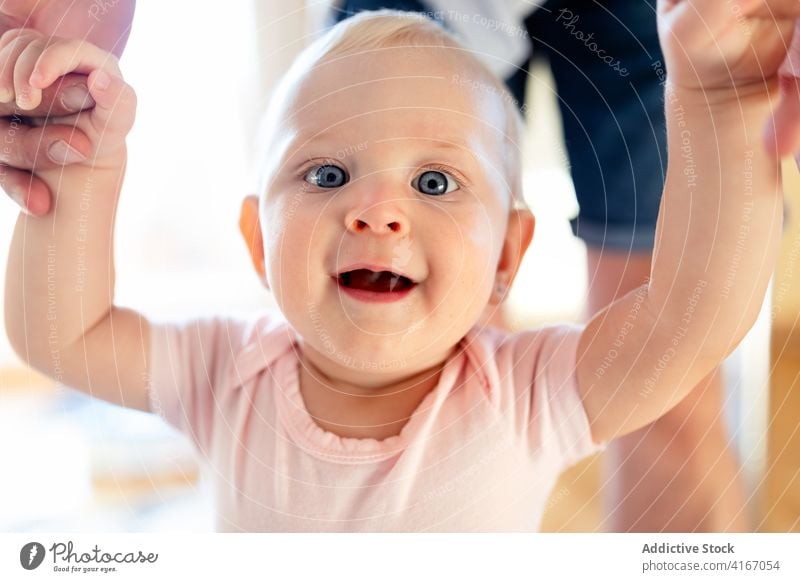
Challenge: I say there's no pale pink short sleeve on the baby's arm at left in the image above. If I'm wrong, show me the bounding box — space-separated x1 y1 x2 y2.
149 318 250 453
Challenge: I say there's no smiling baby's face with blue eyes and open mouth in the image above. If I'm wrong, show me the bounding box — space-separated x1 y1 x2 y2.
260 48 528 374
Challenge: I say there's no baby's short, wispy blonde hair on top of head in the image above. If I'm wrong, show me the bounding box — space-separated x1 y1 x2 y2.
260 9 527 208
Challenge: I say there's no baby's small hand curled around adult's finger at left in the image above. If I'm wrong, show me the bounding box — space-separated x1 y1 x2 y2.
0 28 136 165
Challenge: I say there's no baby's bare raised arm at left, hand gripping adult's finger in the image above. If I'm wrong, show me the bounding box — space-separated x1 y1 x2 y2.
0 29 149 410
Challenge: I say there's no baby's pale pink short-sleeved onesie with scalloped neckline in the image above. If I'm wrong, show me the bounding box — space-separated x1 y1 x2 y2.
150 314 603 532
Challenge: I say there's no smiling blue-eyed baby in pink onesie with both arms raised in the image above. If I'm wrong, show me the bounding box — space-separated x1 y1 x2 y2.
0 2 791 531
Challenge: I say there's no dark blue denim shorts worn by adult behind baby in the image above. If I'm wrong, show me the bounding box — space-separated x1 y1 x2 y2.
332 0 667 251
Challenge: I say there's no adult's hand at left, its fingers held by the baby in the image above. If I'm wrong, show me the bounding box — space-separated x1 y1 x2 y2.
0 0 136 216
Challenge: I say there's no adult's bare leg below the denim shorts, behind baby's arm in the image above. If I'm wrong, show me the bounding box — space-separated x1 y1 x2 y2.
588 247 750 532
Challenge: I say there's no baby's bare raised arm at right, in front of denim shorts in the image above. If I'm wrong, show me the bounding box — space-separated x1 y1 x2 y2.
577 0 788 441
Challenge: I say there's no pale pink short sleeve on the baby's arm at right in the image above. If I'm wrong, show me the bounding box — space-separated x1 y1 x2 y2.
528 325 605 468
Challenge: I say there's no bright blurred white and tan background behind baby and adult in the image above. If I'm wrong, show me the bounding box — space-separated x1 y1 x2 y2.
0 0 800 532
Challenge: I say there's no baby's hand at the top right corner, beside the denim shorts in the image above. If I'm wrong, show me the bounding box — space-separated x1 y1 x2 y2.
658 0 800 105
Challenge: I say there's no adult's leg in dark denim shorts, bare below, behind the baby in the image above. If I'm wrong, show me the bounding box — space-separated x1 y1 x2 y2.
528 0 748 531
